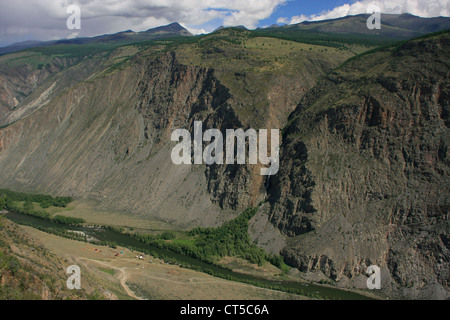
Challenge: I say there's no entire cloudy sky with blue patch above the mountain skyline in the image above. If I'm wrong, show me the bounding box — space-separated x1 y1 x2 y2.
0 0 450 46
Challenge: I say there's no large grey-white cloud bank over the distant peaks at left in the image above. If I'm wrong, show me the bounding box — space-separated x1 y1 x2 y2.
0 0 287 45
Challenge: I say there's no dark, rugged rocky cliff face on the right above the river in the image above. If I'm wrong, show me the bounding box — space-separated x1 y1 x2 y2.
269 34 450 297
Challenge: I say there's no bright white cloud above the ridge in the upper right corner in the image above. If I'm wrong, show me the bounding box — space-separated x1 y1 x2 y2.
290 0 450 24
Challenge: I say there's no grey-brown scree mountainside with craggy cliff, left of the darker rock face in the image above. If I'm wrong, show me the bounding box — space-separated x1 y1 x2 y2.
0 35 348 227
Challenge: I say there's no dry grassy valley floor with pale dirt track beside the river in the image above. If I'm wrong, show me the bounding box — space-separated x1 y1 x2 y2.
21 226 307 300
